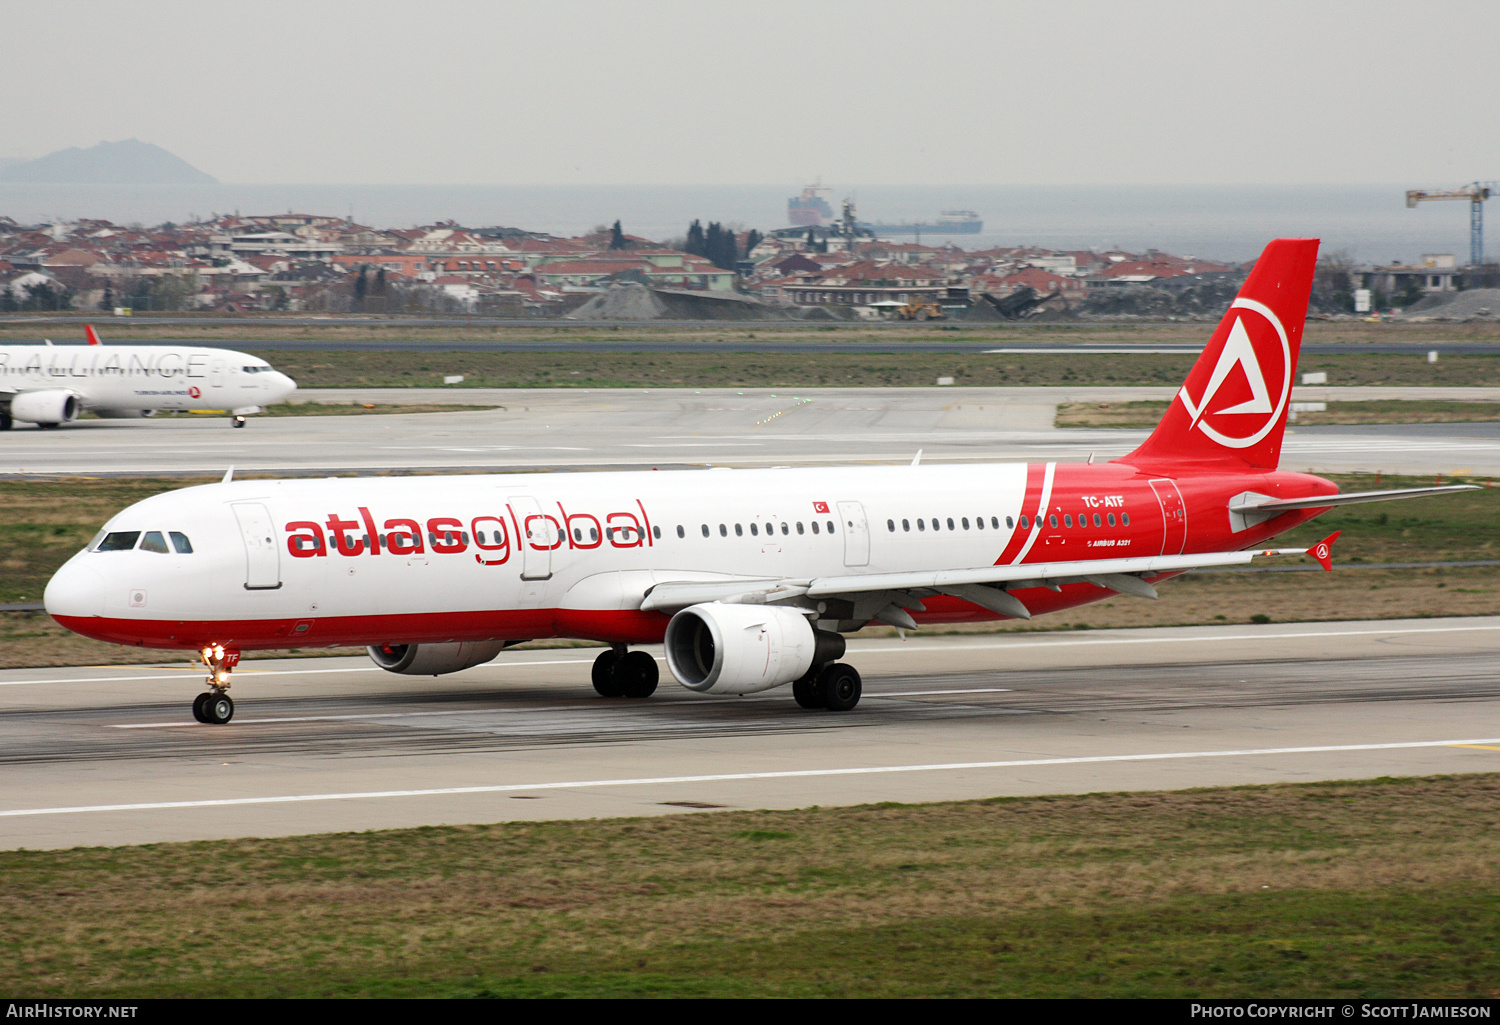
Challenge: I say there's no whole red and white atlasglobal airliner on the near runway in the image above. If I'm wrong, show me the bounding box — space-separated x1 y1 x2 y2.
45 239 1472 725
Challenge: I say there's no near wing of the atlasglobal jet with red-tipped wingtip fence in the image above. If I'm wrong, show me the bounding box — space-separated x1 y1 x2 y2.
641 533 1338 627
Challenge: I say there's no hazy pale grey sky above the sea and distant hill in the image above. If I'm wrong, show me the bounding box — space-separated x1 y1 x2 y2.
0 0 1500 186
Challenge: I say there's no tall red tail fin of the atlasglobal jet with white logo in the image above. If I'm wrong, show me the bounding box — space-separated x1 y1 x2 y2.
1121 239 1319 470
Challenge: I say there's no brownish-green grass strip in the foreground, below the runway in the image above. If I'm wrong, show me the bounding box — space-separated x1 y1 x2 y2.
0 780 1500 998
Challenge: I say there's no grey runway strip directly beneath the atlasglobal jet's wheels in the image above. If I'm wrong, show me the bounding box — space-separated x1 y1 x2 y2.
0 617 1500 848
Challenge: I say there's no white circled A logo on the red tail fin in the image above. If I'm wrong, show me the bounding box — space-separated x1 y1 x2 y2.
1178 299 1292 449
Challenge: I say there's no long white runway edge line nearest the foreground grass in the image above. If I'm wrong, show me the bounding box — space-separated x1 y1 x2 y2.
0 737 1500 818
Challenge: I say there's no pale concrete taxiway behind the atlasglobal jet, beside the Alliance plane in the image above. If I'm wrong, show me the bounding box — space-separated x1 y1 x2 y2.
0 387 1500 476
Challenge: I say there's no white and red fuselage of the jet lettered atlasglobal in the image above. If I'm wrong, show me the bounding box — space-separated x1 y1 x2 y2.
45 464 1320 650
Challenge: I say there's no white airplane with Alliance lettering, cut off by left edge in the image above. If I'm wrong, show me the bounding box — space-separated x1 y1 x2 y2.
0 324 297 431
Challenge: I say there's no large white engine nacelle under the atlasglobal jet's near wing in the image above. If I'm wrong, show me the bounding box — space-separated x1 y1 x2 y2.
665 602 845 693
